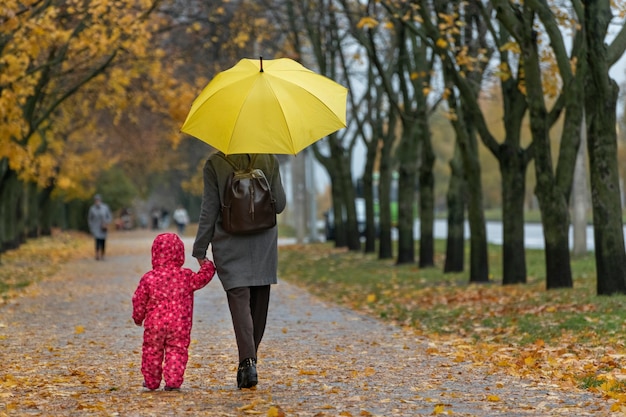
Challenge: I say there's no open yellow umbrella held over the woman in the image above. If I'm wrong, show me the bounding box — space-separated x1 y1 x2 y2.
181 58 348 155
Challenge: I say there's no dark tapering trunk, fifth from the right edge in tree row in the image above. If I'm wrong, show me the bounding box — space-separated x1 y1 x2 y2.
443 142 466 273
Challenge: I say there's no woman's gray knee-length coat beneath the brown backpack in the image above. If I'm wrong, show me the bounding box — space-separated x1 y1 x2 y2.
192 154 286 290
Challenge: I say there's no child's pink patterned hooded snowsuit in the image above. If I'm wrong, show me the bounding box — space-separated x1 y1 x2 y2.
133 233 215 390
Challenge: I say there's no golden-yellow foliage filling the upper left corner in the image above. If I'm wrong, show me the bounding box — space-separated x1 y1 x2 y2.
0 0 173 190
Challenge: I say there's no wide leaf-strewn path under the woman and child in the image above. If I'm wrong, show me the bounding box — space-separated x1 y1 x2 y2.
0 231 611 416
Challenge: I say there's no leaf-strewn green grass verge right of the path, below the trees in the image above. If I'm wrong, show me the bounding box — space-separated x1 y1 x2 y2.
279 241 626 410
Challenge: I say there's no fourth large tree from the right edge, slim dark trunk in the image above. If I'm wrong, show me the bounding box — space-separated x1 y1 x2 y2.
421 1 493 282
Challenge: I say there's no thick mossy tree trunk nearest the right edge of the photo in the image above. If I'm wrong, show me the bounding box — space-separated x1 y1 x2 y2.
584 0 626 295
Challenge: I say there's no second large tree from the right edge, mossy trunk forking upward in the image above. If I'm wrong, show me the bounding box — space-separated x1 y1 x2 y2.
488 2 582 288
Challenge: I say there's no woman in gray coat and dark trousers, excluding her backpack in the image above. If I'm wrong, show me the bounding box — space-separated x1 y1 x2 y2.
192 153 286 388
